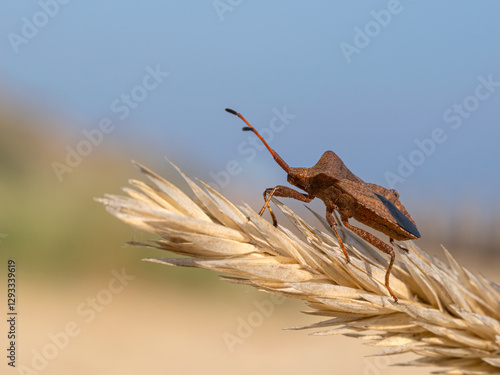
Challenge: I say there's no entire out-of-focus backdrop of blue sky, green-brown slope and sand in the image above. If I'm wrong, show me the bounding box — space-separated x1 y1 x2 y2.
0 0 500 374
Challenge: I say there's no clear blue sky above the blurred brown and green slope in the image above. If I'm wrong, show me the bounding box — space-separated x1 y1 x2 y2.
0 0 500 210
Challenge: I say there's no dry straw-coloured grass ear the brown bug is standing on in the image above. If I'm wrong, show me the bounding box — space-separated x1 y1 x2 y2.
98 163 500 374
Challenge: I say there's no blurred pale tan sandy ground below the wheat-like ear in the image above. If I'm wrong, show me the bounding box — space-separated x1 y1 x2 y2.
1 275 442 375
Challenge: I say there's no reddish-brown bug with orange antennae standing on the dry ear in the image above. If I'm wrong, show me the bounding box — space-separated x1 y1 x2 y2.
226 108 420 302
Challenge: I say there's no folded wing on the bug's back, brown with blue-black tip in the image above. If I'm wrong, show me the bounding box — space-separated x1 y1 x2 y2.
335 180 420 238
